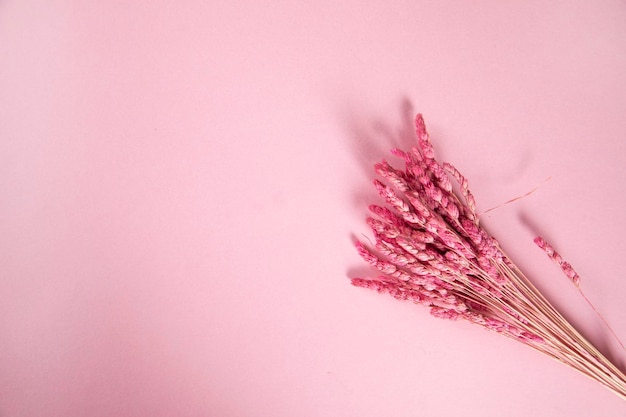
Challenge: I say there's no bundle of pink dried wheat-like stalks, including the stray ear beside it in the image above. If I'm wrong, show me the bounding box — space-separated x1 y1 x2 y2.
352 114 626 399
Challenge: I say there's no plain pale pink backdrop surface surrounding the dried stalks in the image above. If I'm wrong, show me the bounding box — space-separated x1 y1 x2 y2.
0 0 626 417
